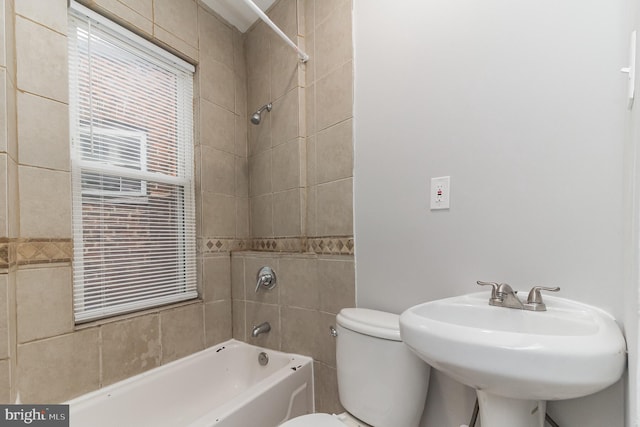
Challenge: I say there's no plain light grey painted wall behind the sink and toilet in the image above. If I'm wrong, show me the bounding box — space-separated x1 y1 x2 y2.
354 0 632 427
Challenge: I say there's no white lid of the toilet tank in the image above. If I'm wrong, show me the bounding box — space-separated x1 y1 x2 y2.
336 308 402 341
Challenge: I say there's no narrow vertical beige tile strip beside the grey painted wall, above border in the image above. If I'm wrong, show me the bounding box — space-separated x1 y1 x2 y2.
304 0 353 241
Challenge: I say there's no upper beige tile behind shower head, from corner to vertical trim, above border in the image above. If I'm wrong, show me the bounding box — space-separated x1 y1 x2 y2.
245 0 306 238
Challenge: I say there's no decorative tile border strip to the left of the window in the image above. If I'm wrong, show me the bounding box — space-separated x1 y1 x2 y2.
0 238 73 268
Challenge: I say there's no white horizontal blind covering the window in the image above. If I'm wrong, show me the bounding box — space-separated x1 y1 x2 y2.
68 1 197 322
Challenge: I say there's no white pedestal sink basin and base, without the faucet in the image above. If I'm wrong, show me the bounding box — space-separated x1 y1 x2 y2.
400 292 626 427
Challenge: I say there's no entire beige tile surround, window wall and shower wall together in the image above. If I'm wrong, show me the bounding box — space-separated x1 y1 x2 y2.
0 0 355 411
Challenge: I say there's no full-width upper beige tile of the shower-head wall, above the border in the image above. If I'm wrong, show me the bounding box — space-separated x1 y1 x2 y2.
245 0 353 244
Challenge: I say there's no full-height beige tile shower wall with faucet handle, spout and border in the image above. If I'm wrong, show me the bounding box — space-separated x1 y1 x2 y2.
241 0 355 412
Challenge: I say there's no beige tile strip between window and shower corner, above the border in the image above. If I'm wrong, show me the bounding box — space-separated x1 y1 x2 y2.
196 1 249 244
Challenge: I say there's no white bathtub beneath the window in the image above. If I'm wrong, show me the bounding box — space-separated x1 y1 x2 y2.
67 340 314 427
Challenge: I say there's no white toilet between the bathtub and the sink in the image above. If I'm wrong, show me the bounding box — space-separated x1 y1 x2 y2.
280 308 431 427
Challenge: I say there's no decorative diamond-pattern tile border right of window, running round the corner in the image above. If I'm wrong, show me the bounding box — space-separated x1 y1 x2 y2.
197 236 354 255
